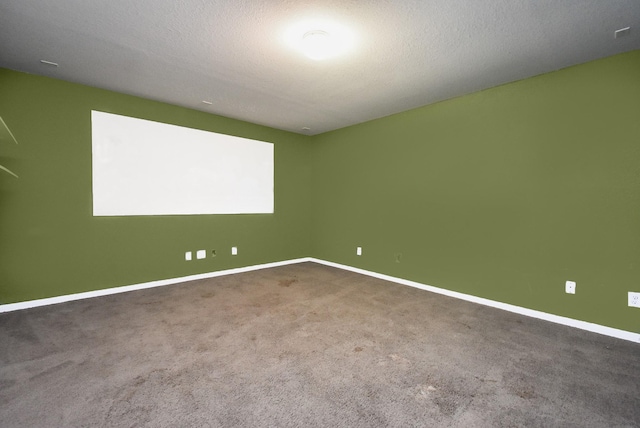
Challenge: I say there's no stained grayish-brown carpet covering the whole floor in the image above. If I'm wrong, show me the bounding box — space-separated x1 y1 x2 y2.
0 263 640 428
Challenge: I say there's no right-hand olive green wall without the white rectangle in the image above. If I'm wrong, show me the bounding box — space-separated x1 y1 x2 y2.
312 51 640 332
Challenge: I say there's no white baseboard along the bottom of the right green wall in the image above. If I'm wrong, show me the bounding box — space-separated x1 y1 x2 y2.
307 257 640 343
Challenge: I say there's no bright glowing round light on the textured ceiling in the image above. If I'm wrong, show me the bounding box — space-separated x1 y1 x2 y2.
283 19 355 61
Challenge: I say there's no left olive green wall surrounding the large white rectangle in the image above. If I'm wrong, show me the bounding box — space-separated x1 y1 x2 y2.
0 70 311 303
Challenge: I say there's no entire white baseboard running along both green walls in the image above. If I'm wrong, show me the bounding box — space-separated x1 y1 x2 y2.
0 257 640 343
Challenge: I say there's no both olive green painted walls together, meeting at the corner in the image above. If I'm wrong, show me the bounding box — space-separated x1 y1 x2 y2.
0 51 640 332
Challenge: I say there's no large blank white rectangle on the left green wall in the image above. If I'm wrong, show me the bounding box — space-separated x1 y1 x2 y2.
91 110 274 216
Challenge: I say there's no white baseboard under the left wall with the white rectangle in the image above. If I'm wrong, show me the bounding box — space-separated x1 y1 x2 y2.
0 257 311 313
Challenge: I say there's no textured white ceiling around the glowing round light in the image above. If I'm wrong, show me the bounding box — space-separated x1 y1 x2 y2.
0 0 640 134
